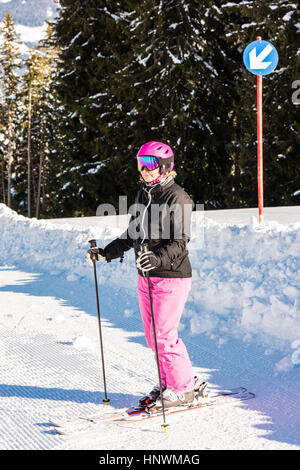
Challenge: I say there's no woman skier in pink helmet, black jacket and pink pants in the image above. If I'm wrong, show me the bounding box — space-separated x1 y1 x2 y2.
88 141 204 408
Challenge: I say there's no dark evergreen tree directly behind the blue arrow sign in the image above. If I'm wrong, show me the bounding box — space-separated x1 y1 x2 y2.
220 0 300 207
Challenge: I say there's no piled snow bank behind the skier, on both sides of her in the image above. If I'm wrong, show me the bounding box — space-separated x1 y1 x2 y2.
0 204 300 372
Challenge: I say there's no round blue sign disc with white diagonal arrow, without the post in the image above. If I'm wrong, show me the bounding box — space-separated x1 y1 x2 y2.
243 39 278 75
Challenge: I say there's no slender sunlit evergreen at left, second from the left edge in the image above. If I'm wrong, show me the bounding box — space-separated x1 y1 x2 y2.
15 27 57 218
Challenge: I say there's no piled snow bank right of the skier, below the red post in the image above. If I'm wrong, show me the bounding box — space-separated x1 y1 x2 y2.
186 218 300 363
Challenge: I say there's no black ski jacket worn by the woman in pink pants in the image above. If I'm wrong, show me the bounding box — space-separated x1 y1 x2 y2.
104 177 194 278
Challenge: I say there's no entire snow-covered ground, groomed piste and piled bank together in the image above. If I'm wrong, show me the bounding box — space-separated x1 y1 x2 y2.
0 204 300 450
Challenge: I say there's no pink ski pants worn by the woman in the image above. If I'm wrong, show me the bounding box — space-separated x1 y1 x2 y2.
138 276 194 393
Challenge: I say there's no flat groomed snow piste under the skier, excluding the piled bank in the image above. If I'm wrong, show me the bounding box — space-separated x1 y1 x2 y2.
0 205 300 450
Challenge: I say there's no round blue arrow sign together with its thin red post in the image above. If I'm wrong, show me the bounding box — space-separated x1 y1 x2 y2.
243 36 278 223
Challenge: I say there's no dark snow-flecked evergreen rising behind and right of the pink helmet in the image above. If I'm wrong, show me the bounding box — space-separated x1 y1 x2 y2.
122 0 241 208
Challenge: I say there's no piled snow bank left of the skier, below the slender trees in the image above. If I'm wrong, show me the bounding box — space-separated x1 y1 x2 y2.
0 204 132 281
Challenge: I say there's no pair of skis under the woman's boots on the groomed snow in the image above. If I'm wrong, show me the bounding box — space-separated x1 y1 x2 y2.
49 387 251 434
